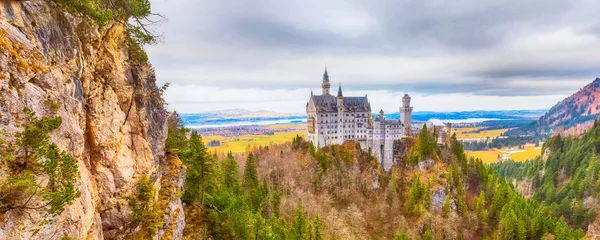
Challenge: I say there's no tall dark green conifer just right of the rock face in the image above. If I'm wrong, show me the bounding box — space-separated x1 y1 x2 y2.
183 131 214 205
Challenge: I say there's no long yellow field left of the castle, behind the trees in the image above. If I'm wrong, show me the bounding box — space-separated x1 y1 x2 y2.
202 131 306 153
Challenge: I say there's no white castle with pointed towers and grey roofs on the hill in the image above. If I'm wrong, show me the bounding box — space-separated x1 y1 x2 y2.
306 68 413 170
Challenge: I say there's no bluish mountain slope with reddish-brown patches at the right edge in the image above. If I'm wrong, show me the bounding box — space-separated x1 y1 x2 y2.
507 78 600 135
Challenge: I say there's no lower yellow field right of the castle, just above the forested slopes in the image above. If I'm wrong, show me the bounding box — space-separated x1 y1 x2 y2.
465 145 542 163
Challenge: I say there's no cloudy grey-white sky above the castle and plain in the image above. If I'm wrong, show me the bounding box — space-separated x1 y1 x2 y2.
146 0 600 113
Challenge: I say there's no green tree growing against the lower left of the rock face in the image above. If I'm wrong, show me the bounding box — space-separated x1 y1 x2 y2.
0 108 80 217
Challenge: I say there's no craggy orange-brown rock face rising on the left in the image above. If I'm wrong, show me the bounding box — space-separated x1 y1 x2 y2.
0 0 184 240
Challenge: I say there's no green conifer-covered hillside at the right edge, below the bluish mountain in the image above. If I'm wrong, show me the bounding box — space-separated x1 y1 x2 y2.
492 121 600 235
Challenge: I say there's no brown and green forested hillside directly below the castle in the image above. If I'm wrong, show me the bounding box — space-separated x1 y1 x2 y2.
167 116 582 239
